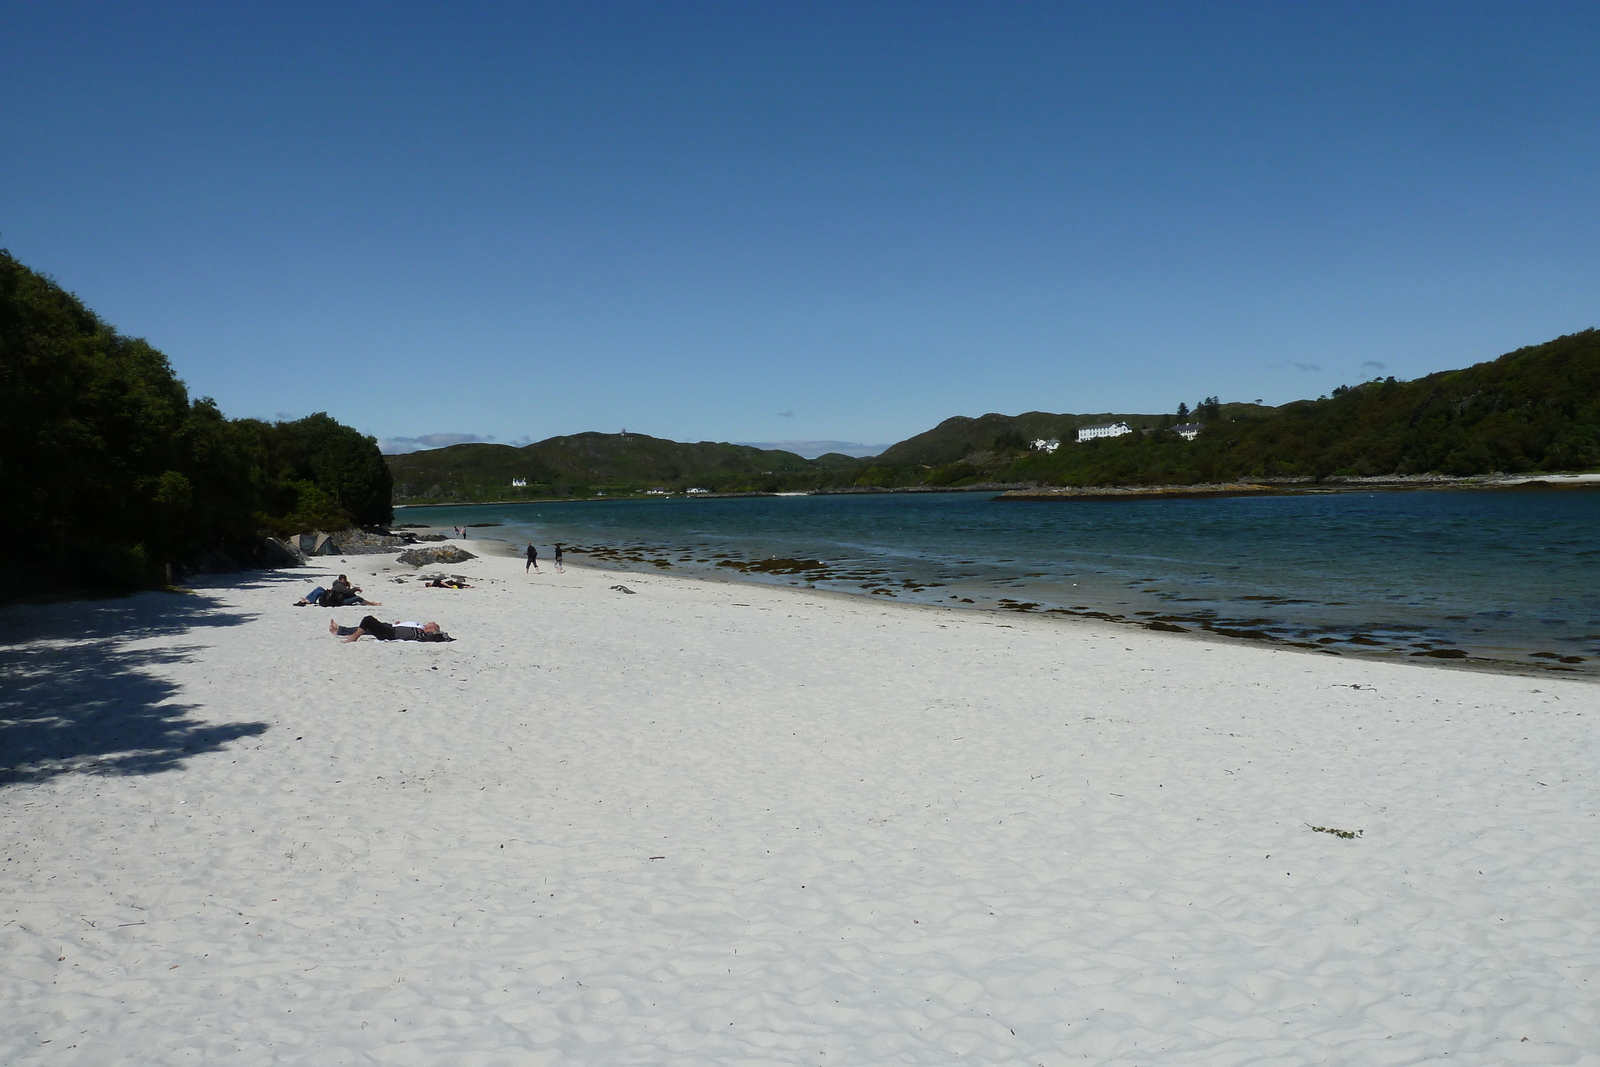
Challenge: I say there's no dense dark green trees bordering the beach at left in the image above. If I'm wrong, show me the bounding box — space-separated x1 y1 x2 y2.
0 250 392 597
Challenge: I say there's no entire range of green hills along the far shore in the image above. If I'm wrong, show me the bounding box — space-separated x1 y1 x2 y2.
389 330 1600 502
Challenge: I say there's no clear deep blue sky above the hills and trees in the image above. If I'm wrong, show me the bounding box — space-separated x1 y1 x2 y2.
0 0 1600 443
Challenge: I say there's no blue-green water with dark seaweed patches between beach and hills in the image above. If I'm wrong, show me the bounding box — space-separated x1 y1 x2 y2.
397 490 1600 672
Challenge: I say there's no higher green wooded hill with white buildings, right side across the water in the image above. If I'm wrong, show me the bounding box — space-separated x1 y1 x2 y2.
858 330 1600 488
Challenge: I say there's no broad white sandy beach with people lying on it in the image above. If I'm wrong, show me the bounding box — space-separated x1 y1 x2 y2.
0 542 1600 1065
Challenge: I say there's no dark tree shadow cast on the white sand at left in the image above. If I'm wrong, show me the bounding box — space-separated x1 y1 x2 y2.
0 576 267 785
